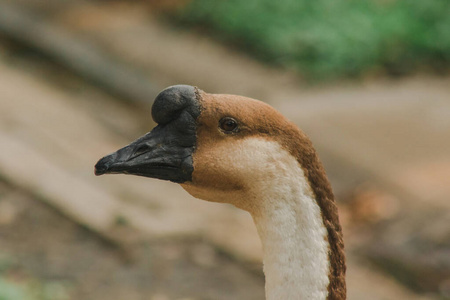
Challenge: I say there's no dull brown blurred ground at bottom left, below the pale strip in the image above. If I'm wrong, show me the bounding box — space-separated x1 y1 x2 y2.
0 182 264 300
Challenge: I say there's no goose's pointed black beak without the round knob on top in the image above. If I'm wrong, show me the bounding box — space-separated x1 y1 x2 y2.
95 124 195 183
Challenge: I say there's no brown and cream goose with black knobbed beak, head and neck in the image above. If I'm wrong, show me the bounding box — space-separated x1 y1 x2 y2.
95 85 346 300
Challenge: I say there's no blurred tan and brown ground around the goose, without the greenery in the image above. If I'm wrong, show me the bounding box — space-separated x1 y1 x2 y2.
0 0 450 300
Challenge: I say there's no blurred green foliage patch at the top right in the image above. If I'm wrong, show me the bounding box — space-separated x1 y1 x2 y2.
177 0 450 79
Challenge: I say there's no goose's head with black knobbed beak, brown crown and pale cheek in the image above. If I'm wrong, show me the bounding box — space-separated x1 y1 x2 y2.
95 85 309 210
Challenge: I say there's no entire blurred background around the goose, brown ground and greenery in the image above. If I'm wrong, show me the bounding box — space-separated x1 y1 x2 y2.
0 0 450 300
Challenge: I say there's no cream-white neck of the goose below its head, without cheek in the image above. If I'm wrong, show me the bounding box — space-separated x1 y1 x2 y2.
252 152 329 300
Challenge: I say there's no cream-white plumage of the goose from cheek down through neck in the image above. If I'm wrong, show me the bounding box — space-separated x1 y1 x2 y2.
183 138 330 300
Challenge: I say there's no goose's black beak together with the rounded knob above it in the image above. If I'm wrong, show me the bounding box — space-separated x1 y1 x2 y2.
95 85 200 183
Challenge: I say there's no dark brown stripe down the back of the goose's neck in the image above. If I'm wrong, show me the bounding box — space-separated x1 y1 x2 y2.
278 124 346 300
